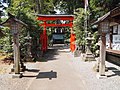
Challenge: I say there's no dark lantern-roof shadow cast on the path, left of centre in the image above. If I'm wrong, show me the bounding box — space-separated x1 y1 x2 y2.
36 70 57 80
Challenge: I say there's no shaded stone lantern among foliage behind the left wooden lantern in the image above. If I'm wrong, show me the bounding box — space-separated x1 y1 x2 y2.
25 32 32 61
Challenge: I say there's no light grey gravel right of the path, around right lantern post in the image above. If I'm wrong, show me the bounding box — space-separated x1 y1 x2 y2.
71 53 120 90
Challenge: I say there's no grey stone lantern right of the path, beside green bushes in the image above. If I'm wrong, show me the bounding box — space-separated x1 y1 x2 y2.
84 33 95 61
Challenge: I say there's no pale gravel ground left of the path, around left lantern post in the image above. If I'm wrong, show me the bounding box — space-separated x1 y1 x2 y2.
0 63 36 90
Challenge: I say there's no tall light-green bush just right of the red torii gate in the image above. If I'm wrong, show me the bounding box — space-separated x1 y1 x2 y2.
74 8 85 45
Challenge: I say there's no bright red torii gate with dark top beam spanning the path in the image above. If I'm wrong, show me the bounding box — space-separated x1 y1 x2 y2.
37 14 75 52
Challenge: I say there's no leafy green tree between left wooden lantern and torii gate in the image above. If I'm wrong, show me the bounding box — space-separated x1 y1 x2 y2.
5 0 41 58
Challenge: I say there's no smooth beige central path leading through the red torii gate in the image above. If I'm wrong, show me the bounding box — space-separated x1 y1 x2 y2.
27 46 86 90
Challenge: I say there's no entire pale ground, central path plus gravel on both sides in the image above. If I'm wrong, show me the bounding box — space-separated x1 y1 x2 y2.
0 46 120 90
